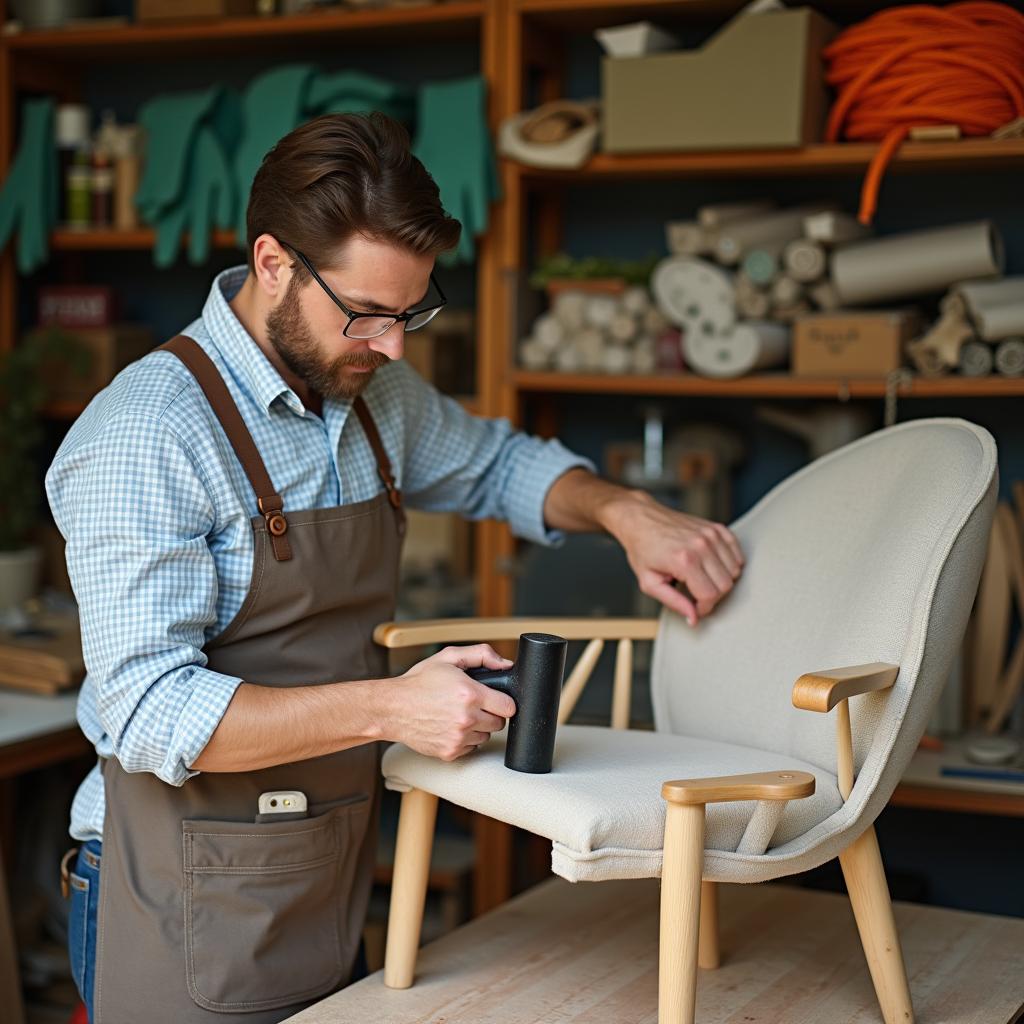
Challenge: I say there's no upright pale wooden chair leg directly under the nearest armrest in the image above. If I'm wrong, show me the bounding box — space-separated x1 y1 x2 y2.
657 803 705 1024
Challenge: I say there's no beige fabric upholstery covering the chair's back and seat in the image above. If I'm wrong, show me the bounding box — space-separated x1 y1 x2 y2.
384 418 997 882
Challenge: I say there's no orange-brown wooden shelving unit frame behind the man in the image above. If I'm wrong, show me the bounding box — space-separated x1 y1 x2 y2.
0 0 1024 910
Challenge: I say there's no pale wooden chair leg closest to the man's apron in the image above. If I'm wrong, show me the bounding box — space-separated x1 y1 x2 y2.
384 790 437 988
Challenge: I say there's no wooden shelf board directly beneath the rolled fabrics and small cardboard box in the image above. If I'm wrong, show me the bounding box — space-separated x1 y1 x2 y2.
512 370 1024 398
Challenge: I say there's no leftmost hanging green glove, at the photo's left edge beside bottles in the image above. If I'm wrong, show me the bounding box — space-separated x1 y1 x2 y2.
0 99 58 273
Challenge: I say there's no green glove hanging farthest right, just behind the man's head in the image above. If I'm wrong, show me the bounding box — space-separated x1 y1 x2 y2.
413 75 500 265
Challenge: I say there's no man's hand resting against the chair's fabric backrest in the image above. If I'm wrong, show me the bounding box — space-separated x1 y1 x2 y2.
608 492 744 626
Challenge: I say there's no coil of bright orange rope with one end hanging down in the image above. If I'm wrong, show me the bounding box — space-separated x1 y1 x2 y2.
823 0 1024 224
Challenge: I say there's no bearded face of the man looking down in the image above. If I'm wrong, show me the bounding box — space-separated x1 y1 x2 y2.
266 236 434 398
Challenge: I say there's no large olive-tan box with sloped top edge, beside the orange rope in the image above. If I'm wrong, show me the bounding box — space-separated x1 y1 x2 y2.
601 7 837 153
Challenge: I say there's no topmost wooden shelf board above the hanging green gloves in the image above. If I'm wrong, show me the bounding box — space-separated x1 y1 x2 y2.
0 0 484 61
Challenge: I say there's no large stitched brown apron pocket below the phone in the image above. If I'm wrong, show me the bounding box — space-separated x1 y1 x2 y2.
181 798 370 1013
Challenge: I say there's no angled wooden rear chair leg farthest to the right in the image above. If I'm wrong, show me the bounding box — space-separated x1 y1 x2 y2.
839 826 913 1024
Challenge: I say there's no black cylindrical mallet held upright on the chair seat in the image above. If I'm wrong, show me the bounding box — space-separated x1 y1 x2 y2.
466 633 567 775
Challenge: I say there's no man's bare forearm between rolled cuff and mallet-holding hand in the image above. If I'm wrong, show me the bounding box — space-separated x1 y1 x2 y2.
189 679 388 772
